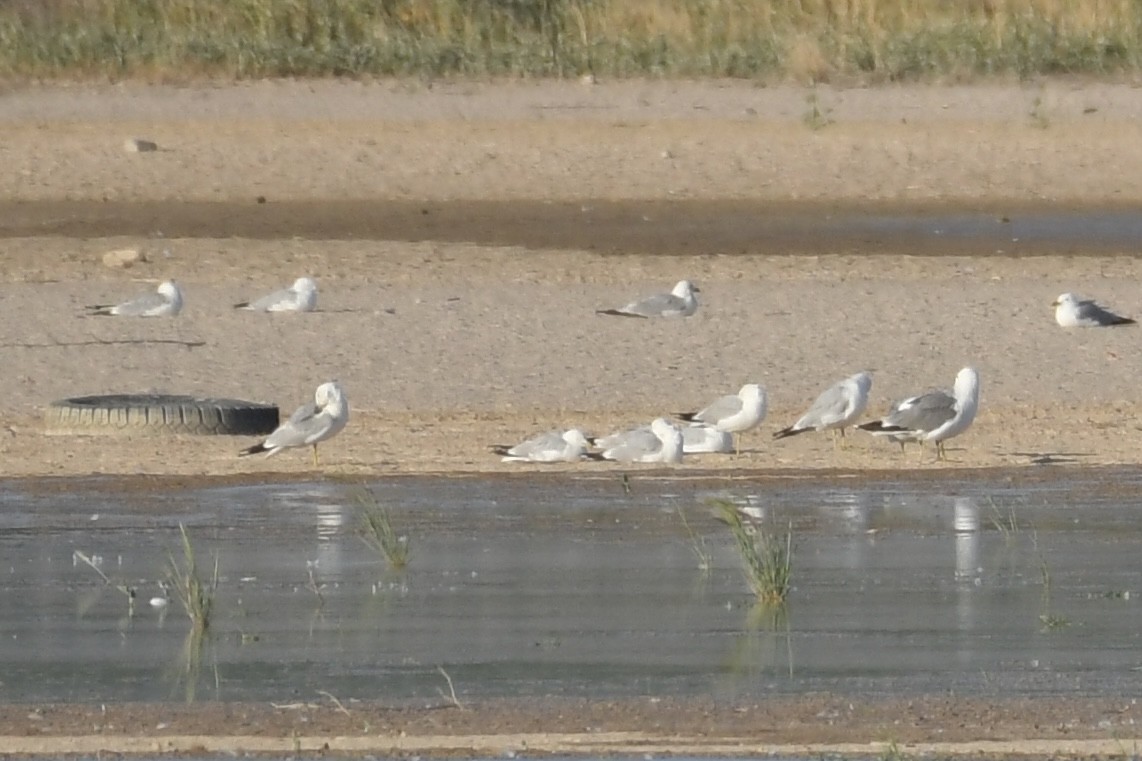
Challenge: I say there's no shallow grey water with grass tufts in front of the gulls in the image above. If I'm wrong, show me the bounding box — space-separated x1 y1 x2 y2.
0 468 1142 702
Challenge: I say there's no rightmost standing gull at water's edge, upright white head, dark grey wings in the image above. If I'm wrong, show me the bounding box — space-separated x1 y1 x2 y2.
859 367 980 459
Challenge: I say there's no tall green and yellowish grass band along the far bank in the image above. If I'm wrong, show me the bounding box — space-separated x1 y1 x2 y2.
0 0 1142 83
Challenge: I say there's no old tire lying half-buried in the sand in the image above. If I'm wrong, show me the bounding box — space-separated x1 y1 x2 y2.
45 394 279 436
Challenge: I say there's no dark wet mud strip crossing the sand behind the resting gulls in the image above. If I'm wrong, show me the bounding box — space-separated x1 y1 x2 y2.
0 198 1142 256
